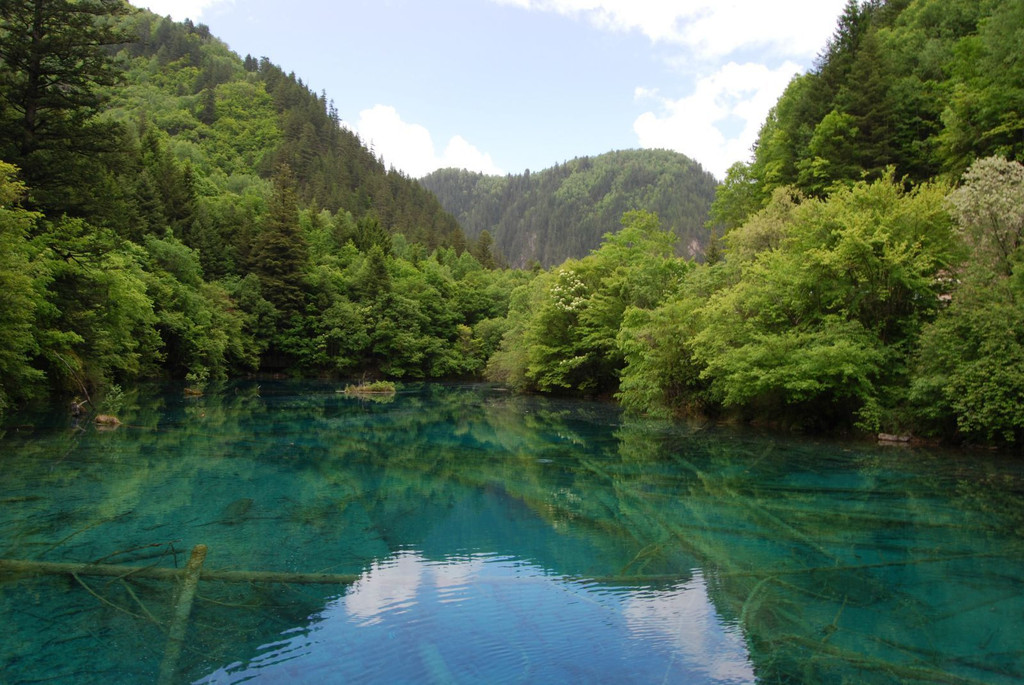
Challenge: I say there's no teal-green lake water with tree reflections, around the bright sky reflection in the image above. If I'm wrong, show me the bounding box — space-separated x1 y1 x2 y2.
0 383 1024 682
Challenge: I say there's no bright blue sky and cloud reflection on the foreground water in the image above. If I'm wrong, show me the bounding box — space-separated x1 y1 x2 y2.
201 551 754 685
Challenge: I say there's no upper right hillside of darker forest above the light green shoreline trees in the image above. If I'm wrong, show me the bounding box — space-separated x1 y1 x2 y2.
714 0 1024 227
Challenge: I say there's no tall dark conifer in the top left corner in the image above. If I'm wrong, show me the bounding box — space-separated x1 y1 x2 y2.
0 0 128 214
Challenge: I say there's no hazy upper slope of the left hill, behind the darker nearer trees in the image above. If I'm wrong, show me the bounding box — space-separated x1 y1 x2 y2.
106 12 464 255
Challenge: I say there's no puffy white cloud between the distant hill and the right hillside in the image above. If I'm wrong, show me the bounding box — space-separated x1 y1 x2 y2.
633 61 801 179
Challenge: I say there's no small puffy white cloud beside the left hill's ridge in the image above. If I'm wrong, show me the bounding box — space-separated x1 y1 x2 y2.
355 104 504 178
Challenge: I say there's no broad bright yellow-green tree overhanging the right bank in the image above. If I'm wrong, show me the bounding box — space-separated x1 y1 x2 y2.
693 177 958 429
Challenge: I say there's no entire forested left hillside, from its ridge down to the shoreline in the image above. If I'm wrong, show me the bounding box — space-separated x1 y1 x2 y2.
0 0 523 411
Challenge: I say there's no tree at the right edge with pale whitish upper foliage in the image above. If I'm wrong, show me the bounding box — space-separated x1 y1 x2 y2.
912 158 1024 442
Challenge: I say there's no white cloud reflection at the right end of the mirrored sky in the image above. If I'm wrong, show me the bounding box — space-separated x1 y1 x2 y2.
623 573 755 683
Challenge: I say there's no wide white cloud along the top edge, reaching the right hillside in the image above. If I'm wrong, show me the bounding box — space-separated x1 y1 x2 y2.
493 0 846 58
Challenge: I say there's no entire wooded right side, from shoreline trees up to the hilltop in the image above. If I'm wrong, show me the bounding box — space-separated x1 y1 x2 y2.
488 0 1024 444
